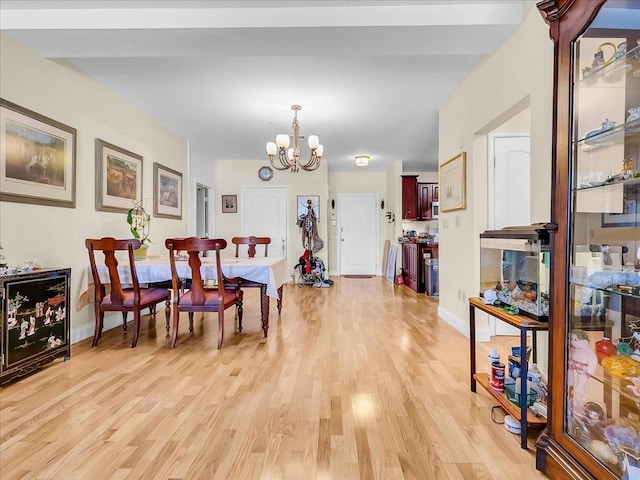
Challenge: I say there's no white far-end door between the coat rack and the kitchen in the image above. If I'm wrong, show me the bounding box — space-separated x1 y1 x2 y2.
338 195 380 275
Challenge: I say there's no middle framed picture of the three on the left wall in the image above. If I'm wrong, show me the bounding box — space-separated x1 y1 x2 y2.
96 138 142 213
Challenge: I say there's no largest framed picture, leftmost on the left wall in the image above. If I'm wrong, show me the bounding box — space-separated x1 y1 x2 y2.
0 98 77 208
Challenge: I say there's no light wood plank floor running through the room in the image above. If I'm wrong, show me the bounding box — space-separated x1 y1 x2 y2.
0 277 544 480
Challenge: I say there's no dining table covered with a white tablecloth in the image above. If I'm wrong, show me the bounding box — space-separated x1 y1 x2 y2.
77 255 291 337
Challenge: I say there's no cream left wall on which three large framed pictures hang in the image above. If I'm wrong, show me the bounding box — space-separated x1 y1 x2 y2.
0 35 189 342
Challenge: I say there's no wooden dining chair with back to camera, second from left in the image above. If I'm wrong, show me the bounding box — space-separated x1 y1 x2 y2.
165 237 242 349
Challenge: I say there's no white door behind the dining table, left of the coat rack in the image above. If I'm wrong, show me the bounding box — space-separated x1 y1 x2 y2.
241 186 288 258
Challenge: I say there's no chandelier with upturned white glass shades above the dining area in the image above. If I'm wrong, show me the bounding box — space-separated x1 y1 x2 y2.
267 105 324 172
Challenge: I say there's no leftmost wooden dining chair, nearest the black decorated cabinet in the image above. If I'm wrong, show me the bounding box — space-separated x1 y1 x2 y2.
84 237 171 348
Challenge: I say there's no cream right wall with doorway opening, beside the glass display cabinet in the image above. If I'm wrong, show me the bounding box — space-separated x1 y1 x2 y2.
439 9 553 344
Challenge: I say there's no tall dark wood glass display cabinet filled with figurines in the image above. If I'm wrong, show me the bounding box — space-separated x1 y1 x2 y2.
537 0 640 480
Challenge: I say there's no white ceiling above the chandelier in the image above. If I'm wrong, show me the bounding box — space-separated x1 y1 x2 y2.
0 0 532 172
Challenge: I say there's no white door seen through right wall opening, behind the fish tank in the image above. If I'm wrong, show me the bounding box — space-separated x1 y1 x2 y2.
488 134 531 335
